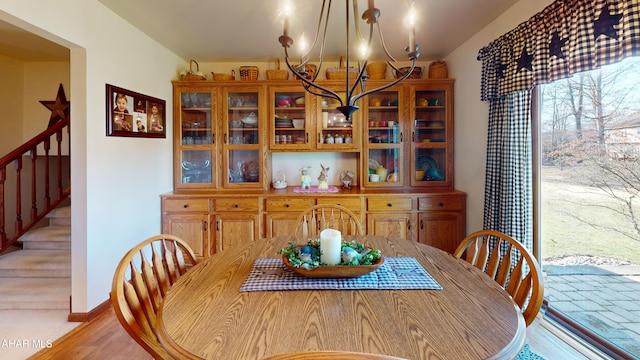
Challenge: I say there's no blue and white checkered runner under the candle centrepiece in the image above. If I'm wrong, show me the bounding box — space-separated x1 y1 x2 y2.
240 257 442 292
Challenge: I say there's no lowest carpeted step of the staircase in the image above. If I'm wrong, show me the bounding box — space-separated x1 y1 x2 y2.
0 278 71 310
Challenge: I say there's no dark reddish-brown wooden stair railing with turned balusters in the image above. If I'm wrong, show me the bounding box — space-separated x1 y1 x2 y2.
0 117 71 252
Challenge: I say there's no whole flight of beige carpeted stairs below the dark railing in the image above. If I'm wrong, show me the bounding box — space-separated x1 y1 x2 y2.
0 206 71 310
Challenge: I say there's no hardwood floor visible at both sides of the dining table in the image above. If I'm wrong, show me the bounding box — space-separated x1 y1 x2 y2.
29 308 598 360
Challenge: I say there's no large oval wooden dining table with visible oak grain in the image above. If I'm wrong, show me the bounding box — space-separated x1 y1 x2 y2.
157 236 526 360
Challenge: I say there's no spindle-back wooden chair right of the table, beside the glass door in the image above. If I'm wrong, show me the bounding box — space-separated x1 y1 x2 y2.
453 230 544 326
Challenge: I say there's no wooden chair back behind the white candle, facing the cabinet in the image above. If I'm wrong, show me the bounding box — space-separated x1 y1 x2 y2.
295 204 364 237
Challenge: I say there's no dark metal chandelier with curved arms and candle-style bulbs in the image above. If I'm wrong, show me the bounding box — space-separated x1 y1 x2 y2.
278 0 420 121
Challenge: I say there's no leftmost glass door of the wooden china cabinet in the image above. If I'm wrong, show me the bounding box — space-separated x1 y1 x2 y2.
176 90 216 188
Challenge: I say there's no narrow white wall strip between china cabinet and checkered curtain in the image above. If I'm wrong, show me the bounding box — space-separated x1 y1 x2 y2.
445 0 553 233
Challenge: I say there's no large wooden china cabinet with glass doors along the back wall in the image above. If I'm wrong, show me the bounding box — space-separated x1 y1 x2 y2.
161 79 466 257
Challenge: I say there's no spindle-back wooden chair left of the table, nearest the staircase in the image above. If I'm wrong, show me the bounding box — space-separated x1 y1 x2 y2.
111 234 196 359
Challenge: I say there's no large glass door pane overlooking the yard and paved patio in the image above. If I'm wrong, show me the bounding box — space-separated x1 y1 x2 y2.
538 57 640 357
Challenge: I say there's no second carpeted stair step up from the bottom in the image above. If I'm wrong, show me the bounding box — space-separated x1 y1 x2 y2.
0 250 71 278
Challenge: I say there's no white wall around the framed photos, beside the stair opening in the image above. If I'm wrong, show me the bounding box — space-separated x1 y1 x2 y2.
0 0 185 313
